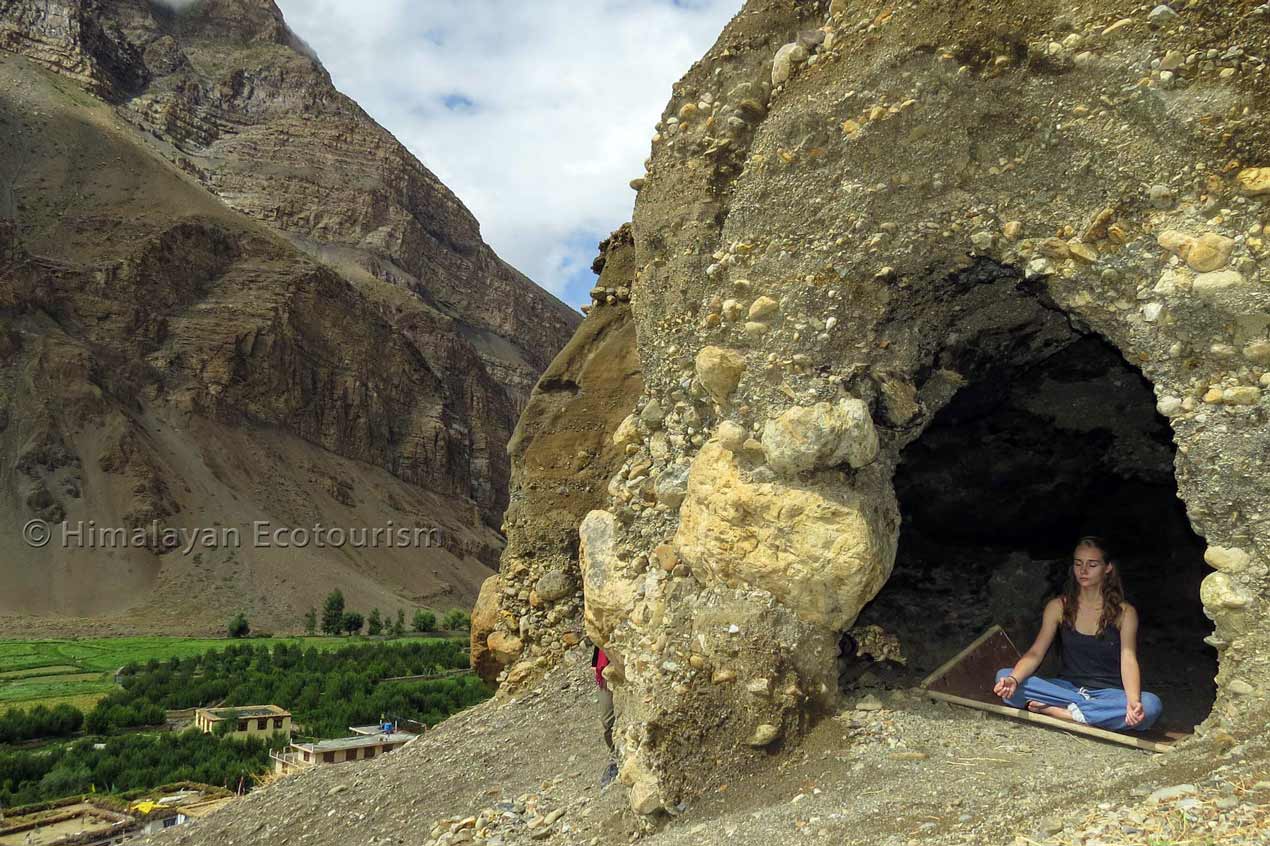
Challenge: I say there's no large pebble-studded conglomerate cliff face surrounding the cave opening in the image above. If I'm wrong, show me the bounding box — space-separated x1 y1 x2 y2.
485 0 1270 813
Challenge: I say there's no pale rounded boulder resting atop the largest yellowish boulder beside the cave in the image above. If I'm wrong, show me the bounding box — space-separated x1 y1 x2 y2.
763 398 878 474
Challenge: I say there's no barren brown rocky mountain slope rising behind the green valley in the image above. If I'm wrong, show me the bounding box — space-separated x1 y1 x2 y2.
0 0 580 630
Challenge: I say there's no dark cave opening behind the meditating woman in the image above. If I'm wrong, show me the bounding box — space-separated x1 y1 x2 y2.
842 335 1217 729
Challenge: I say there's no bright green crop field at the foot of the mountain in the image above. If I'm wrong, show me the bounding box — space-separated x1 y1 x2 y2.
0 636 457 711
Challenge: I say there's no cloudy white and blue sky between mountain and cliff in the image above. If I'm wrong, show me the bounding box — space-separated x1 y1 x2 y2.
277 0 742 304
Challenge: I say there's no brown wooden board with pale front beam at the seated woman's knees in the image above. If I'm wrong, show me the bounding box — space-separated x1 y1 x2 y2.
921 626 1186 752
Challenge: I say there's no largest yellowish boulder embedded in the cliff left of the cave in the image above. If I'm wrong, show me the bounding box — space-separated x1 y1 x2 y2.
674 441 898 629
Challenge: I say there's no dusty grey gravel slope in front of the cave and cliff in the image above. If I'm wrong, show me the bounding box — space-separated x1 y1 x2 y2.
147 650 1270 846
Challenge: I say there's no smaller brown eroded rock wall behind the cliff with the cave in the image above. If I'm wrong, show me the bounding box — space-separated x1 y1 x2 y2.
471 225 640 687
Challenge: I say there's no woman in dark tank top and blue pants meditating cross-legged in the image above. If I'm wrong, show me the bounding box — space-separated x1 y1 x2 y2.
992 536 1163 732
